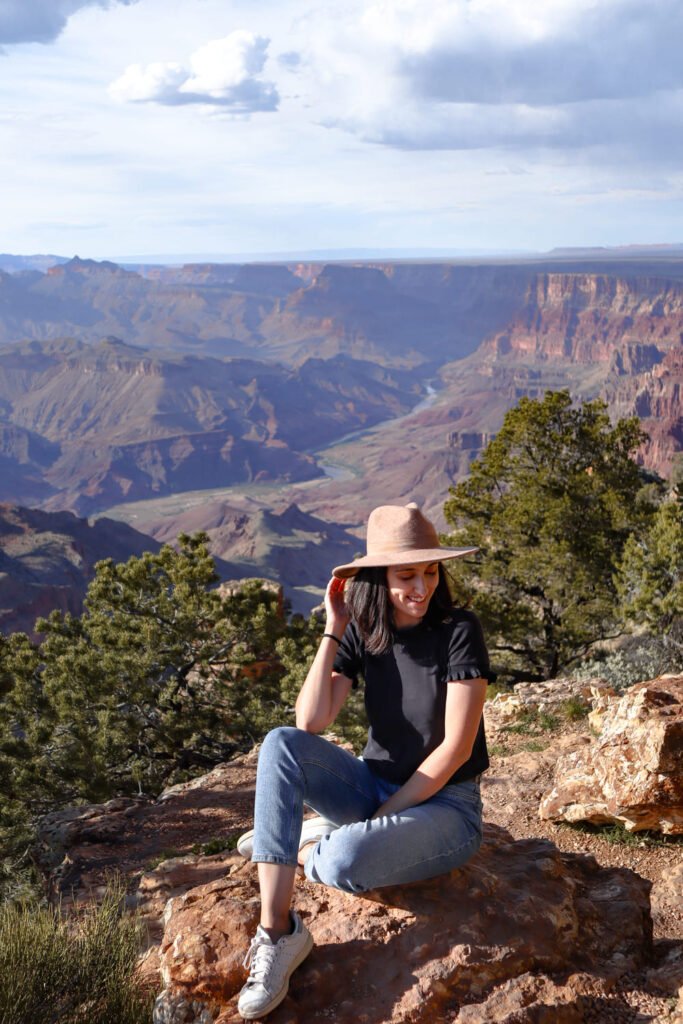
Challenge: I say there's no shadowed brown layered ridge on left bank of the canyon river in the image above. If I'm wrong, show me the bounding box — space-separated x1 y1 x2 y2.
0 338 422 514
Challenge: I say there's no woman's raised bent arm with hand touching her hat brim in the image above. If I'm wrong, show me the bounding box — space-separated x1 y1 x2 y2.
296 578 352 732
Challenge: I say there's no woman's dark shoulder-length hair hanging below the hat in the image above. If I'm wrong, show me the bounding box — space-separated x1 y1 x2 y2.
345 562 453 654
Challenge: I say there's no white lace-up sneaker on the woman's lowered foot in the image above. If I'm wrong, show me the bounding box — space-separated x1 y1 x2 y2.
238 910 313 1020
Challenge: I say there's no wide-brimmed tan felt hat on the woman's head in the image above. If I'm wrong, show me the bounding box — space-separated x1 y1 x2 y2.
332 502 479 580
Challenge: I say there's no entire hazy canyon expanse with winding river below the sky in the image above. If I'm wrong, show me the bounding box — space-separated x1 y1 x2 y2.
0 254 683 618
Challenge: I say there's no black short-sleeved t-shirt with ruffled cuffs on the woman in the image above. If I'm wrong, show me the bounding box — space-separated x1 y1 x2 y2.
333 608 496 785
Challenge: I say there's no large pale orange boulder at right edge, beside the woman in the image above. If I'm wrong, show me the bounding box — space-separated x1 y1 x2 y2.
539 676 683 835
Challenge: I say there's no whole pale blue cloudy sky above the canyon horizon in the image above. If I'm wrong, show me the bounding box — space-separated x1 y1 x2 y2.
0 0 683 258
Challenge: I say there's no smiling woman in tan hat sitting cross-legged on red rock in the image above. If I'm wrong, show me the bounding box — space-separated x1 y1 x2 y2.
238 504 495 1019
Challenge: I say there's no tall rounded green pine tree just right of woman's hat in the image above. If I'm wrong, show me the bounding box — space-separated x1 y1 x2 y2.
444 391 658 681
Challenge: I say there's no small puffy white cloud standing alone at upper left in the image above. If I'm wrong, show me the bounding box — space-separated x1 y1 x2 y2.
110 30 280 114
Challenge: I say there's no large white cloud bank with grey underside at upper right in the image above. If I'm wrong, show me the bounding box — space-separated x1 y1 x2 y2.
306 0 683 159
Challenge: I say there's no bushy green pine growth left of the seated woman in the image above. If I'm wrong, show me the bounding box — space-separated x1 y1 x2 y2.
0 535 289 897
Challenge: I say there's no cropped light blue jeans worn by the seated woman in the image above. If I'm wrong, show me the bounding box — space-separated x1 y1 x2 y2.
252 727 481 893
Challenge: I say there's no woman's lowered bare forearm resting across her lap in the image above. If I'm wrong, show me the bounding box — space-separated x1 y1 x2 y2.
373 679 486 818
